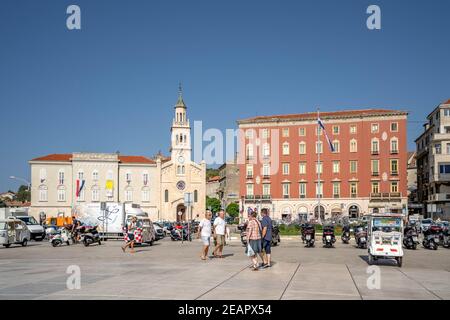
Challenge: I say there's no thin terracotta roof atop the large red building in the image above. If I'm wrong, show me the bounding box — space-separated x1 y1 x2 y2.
238 109 407 123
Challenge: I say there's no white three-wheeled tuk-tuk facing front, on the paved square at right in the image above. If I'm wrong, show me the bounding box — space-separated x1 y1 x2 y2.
368 213 403 267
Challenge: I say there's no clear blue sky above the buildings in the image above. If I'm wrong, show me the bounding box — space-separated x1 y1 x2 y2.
0 0 450 191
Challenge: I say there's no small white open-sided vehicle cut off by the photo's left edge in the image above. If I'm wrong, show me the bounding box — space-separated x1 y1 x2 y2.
0 217 31 248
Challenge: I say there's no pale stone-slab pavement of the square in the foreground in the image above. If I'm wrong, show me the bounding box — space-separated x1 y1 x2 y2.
0 238 450 300
